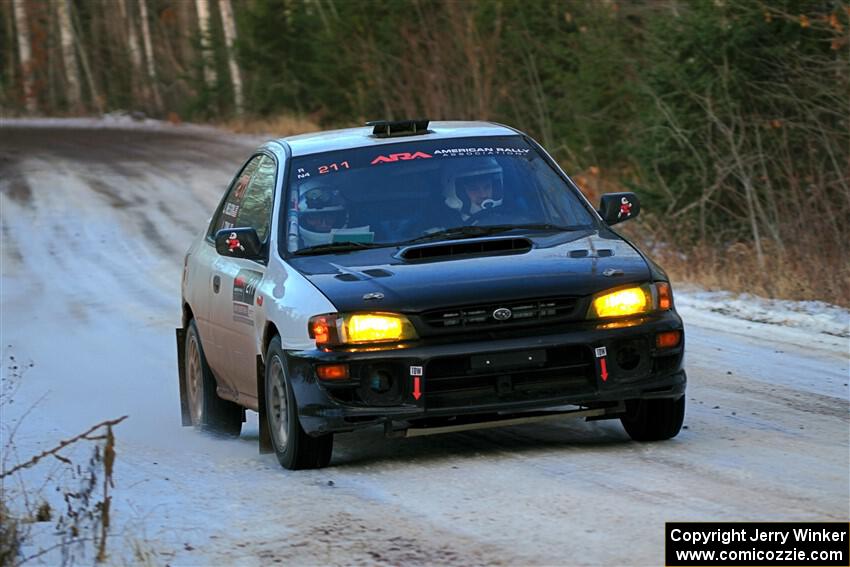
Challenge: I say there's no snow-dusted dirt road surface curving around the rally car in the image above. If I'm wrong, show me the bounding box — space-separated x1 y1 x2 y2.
0 123 850 565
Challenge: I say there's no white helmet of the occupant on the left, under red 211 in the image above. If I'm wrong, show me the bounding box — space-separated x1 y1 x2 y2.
298 181 348 247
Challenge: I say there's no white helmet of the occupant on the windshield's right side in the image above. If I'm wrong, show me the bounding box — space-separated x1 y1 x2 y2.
444 158 503 220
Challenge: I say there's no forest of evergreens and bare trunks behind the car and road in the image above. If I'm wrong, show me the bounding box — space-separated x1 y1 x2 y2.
0 0 850 306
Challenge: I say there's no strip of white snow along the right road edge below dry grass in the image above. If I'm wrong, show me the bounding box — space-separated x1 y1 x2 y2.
675 287 850 338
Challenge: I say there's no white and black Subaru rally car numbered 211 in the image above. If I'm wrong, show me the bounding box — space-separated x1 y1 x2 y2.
177 120 686 469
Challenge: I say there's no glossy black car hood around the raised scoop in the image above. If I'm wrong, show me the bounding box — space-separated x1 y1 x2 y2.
289 230 650 313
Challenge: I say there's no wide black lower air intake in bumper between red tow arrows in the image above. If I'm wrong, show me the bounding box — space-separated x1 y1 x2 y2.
425 346 596 409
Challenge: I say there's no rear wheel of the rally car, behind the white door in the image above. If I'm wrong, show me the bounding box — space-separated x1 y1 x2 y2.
185 319 244 437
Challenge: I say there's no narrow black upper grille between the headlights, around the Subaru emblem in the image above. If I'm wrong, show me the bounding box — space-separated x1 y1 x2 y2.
422 297 578 329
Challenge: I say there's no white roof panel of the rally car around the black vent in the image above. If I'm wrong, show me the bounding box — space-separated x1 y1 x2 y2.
276 121 519 156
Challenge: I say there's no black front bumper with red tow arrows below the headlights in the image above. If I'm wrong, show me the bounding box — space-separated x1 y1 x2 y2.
286 311 686 435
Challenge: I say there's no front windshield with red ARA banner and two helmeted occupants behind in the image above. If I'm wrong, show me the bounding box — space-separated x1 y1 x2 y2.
282 136 593 253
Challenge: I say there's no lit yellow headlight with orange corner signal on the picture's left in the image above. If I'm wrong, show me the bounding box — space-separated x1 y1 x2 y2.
308 313 417 346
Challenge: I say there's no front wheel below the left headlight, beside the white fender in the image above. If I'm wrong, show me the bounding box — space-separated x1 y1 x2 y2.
265 337 333 470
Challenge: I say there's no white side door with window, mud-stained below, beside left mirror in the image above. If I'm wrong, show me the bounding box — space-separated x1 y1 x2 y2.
206 151 277 397
